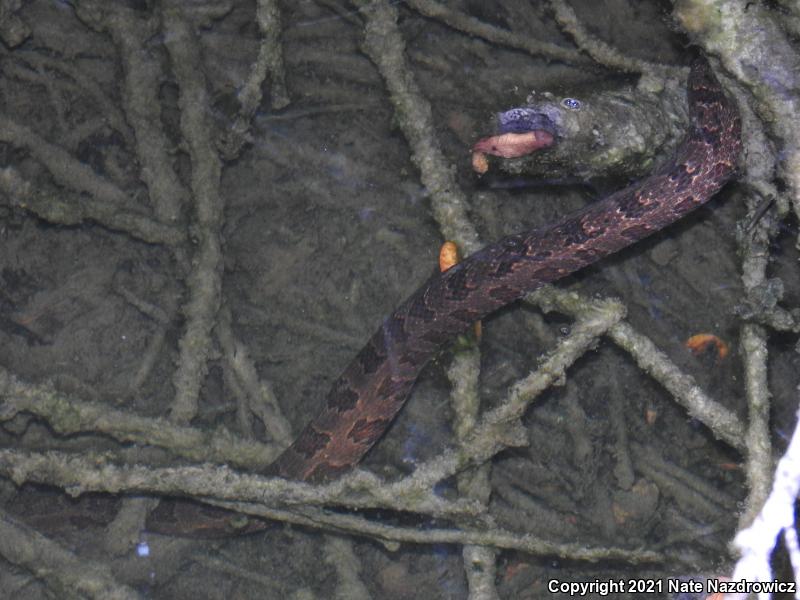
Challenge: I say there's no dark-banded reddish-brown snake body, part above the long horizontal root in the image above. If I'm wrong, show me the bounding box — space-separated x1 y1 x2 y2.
268 59 741 482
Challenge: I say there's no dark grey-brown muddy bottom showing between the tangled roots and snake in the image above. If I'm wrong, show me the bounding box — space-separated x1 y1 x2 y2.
0 0 800 600
